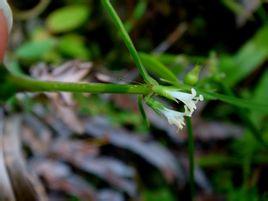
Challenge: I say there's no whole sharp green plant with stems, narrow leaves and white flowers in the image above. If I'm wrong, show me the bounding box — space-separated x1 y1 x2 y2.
1 0 268 200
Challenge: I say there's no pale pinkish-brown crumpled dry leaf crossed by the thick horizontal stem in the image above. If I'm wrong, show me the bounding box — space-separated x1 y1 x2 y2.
28 61 92 134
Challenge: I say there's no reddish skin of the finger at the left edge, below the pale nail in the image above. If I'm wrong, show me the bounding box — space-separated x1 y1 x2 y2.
0 10 8 61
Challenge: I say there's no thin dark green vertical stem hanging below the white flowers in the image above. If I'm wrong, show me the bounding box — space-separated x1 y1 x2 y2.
186 117 195 201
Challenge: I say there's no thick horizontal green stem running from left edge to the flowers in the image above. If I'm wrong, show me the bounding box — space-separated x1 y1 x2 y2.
6 75 151 95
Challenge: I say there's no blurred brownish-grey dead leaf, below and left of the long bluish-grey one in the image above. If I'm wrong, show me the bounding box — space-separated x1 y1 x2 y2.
51 140 136 195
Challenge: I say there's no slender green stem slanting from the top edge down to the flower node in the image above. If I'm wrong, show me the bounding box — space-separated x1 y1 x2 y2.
102 0 157 84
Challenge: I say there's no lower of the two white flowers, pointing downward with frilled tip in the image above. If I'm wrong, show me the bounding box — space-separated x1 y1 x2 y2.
160 107 185 130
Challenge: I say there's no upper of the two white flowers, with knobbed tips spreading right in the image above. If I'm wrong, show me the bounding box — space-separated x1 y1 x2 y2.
165 88 204 116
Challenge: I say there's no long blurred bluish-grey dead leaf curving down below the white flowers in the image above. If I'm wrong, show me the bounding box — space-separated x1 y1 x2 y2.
85 118 185 183
